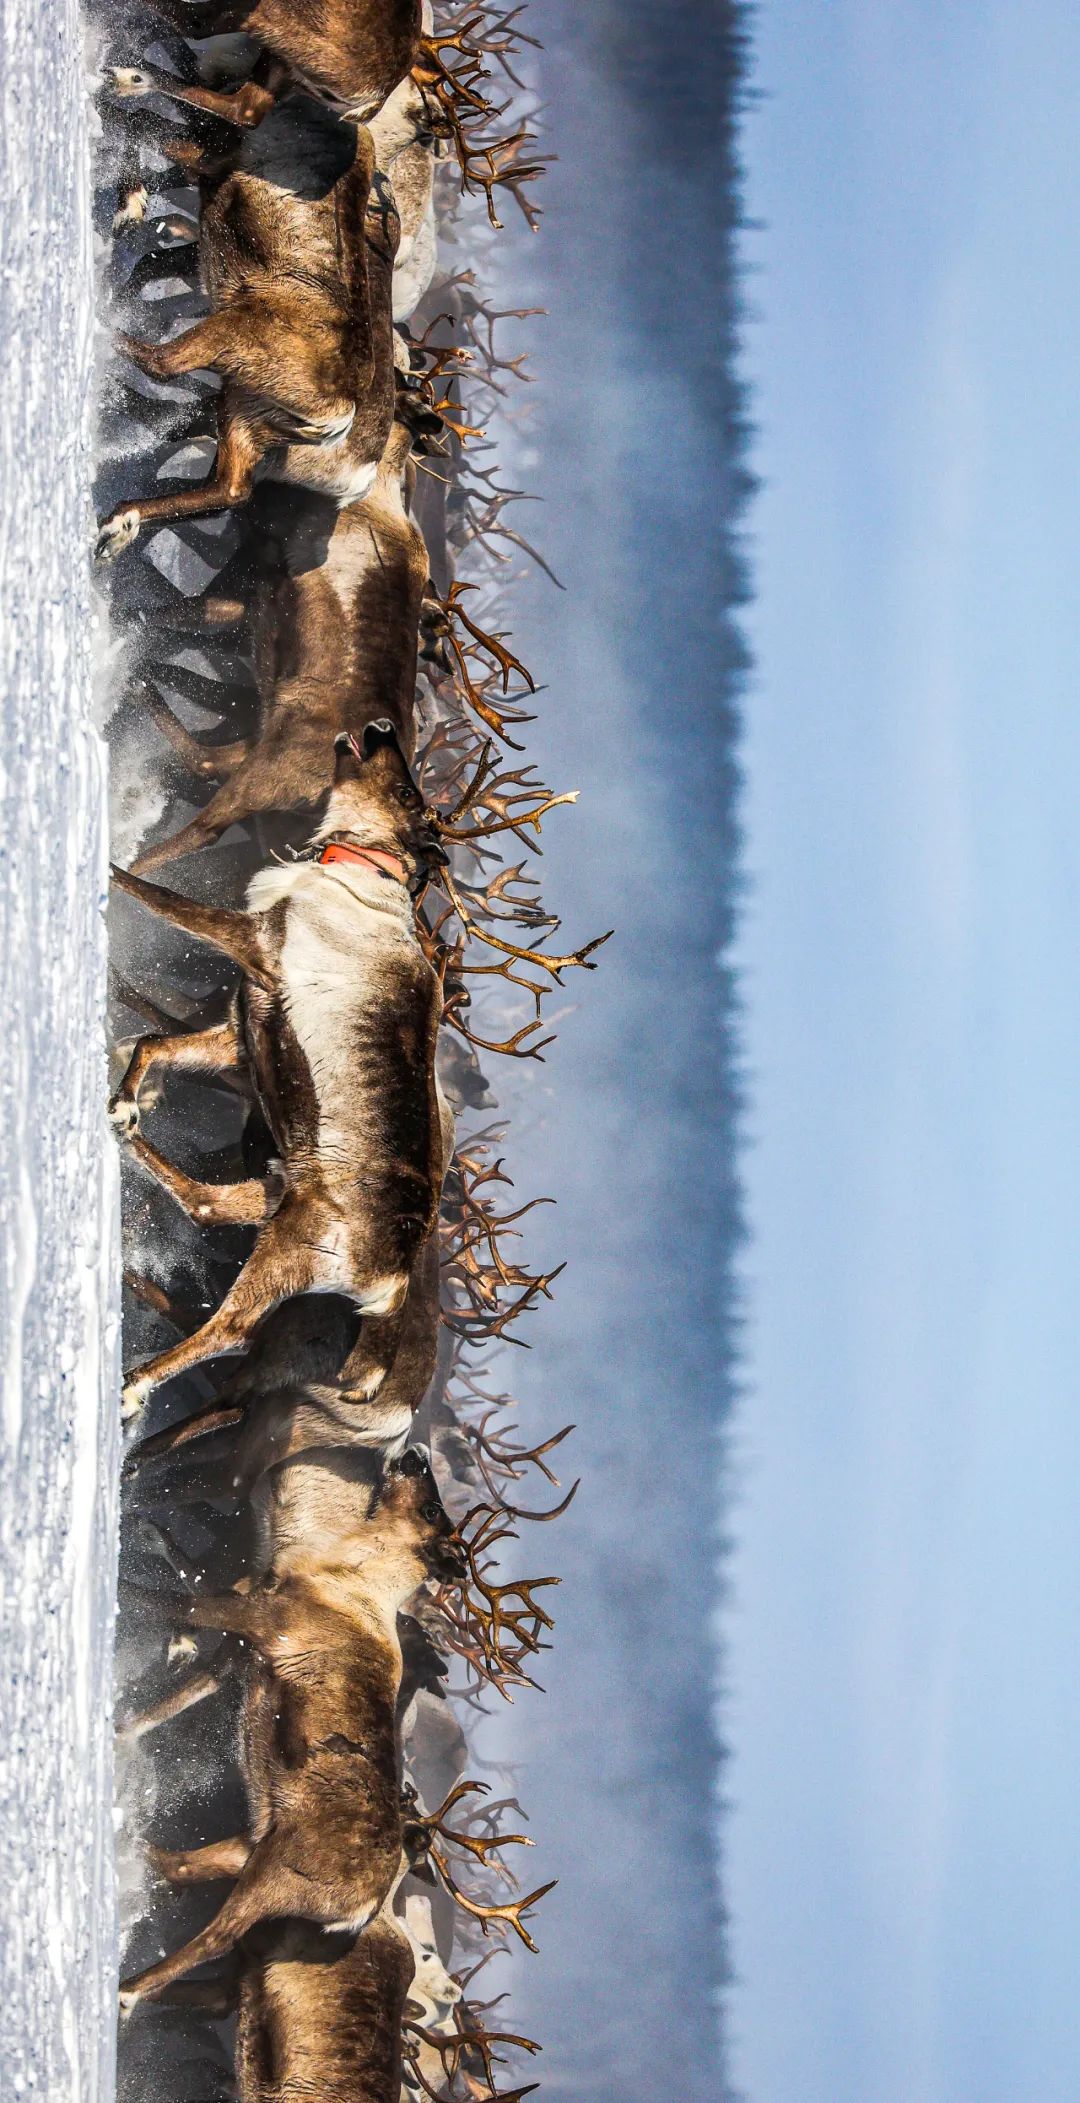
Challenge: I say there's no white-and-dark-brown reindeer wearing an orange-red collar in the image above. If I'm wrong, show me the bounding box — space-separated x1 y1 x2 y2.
111 719 452 1415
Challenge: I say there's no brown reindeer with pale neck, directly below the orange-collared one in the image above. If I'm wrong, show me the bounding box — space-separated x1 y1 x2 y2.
120 1451 464 2010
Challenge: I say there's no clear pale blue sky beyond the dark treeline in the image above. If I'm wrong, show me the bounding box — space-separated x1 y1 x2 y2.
725 0 1080 2103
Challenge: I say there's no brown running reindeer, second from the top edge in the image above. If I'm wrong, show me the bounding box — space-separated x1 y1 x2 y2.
97 82 437 562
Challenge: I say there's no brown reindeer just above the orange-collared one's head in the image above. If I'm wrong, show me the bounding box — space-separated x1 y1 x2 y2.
132 423 429 875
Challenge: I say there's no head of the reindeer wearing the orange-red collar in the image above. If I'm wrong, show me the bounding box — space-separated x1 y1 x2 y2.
315 715 445 890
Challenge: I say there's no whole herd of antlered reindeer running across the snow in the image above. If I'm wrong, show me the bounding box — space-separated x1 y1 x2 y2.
97 0 599 2103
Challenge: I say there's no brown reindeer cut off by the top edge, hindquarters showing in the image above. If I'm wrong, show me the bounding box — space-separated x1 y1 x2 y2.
107 0 422 128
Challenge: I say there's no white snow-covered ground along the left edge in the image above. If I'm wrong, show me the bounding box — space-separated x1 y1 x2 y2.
0 0 120 2103
